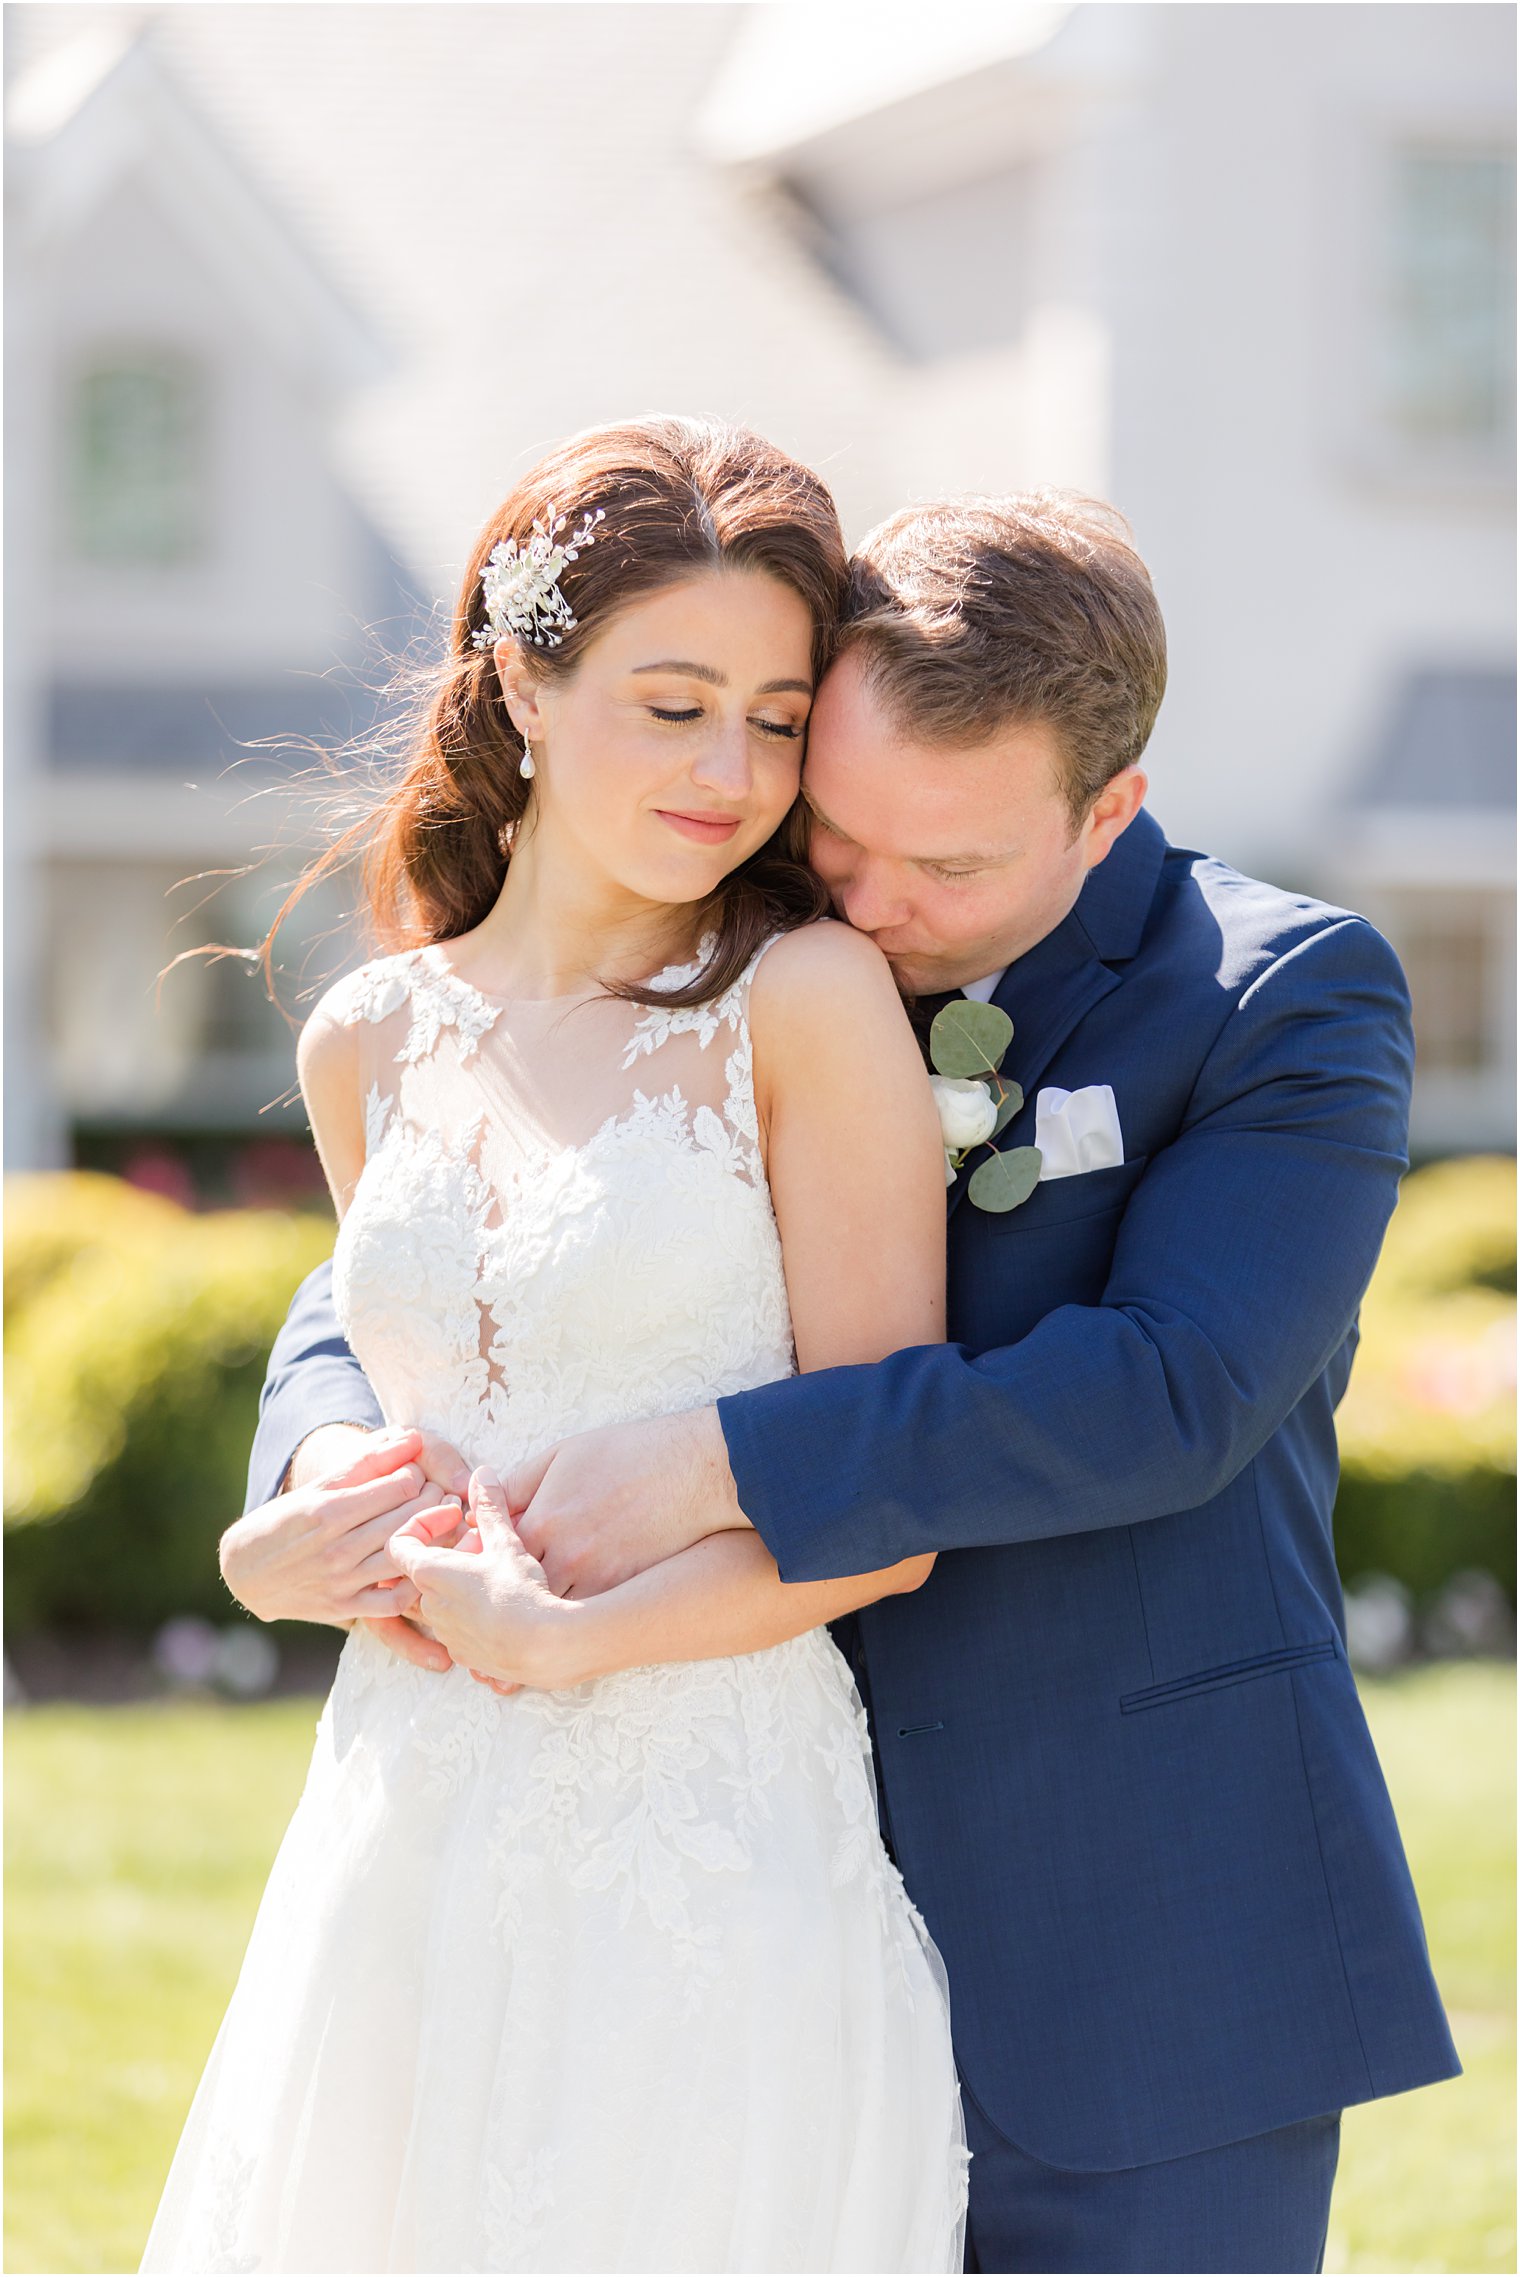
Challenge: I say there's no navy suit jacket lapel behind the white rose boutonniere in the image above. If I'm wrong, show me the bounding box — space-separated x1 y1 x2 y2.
949 811 1167 1214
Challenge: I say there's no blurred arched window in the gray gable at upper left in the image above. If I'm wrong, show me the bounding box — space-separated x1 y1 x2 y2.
68 351 207 567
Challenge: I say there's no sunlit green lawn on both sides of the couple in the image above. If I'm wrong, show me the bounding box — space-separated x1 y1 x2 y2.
5 1667 1515 2272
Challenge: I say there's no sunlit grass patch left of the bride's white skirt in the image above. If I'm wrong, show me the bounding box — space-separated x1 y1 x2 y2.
5 1699 316 2270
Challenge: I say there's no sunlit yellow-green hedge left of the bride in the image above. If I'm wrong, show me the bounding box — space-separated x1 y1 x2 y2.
5 1173 332 1635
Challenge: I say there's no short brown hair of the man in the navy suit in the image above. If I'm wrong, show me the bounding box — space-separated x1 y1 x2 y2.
840 490 1167 824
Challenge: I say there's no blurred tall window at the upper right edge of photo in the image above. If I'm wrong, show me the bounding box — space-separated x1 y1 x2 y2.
1379 148 1515 455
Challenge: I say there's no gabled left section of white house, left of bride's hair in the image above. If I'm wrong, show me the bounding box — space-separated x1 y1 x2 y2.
7 27 410 1161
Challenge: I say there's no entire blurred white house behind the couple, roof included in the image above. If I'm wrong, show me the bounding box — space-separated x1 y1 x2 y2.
5 0 1515 1200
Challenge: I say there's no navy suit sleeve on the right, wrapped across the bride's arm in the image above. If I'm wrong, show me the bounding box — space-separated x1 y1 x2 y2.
719 918 1413 1580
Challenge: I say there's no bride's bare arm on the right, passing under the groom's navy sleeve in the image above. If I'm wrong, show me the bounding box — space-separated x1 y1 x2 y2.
491 922 944 1685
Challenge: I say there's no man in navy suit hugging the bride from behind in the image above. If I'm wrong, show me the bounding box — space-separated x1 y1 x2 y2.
225 494 1459 2270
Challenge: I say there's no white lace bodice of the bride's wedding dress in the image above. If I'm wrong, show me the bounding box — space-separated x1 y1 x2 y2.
328 950 794 1469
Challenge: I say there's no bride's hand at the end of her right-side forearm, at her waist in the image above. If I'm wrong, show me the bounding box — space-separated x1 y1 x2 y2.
387 1471 596 1692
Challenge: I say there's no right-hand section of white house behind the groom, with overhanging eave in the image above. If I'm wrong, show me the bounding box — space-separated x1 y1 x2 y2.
701 0 1515 1150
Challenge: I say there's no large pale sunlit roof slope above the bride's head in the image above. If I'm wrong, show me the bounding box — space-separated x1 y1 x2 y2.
7 0 897 594
